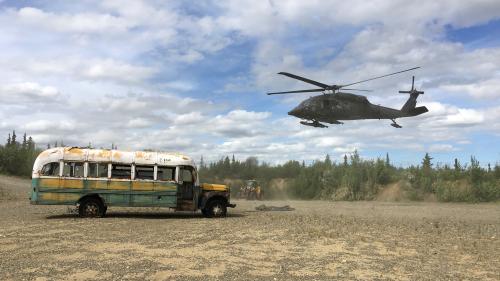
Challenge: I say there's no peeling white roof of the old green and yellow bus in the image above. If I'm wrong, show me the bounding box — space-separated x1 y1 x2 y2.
33 147 195 170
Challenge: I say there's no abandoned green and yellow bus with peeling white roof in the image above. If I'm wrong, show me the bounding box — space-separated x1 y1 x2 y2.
30 147 235 217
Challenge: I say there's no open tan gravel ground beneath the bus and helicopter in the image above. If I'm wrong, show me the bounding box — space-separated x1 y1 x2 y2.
0 174 500 280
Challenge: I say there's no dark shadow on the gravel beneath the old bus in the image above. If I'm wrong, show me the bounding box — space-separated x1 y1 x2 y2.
46 212 246 220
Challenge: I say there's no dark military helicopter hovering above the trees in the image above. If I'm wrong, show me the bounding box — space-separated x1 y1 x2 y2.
267 67 429 128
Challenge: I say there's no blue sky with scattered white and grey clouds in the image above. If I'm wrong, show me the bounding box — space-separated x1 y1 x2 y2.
0 0 500 166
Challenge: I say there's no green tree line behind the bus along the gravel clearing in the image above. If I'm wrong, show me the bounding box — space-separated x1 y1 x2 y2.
0 131 500 202
